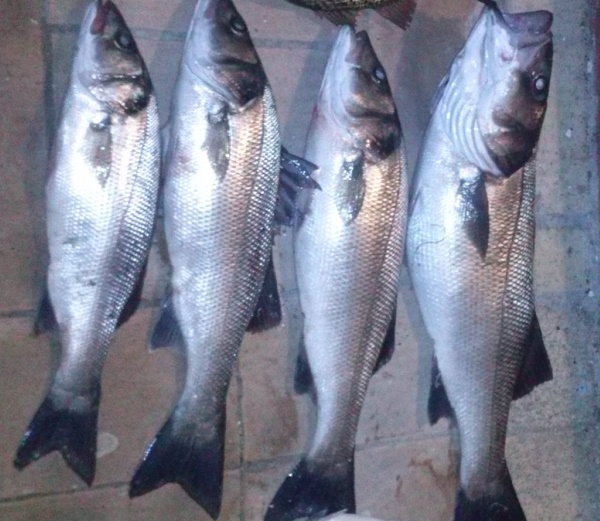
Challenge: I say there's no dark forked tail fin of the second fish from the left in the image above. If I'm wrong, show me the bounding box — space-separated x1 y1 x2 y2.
129 411 225 519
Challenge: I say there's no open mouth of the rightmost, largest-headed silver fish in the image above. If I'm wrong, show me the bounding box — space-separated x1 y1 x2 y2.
485 1 554 49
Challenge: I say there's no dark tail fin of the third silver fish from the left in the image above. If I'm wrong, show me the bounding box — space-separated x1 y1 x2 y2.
265 455 356 521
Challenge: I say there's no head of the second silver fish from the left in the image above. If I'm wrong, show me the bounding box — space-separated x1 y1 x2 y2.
184 0 267 110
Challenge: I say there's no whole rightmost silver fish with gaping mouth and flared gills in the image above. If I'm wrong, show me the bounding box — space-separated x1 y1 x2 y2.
407 2 552 521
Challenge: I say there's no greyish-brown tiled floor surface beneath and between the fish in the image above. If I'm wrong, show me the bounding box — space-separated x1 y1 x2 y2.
0 0 600 521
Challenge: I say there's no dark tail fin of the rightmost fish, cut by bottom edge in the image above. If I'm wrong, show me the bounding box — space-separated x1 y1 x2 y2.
454 468 527 521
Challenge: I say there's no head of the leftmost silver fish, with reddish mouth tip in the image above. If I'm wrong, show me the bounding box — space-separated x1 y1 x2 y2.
74 0 153 114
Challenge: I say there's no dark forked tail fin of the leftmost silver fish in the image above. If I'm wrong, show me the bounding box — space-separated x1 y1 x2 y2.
13 385 100 486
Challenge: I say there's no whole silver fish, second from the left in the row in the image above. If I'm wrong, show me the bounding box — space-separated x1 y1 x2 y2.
130 0 280 518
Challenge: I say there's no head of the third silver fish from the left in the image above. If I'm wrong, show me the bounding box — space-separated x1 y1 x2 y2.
320 26 401 160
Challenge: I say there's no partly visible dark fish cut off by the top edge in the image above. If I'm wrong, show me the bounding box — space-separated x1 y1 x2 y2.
288 0 417 29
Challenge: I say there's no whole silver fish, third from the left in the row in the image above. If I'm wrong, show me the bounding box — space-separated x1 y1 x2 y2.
265 26 408 521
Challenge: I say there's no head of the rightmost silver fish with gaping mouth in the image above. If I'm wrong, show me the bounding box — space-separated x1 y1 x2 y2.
477 3 553 176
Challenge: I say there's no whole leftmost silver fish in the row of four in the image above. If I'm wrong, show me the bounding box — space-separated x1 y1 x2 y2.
15 1 160 484
